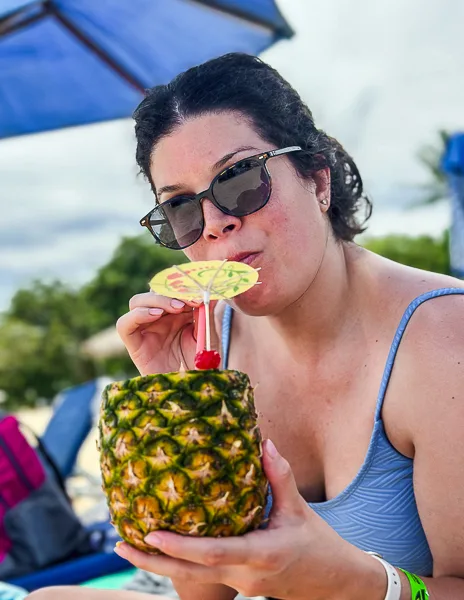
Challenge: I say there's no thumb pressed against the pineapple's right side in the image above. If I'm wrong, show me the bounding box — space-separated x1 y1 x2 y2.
263 440 306 513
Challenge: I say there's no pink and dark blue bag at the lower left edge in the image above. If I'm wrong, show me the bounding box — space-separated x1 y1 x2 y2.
0 411 95 581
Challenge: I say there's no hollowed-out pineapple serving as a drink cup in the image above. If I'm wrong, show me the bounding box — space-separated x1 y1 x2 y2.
99 369 267 553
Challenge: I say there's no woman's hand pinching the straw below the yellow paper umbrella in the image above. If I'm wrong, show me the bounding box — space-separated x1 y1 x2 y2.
116 292 216 375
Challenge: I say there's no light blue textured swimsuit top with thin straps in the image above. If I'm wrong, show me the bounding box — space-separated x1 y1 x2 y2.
222 288 464 576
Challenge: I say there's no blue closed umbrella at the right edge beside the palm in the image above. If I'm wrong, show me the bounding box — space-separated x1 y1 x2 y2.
442 133 464 279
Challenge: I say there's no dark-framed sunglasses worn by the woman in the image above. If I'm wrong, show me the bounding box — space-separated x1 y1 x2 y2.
140 146 301 250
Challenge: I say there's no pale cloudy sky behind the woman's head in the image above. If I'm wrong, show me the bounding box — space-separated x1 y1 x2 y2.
0 0 464 310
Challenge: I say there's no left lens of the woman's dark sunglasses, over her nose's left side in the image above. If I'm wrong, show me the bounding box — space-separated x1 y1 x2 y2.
150 196 203 250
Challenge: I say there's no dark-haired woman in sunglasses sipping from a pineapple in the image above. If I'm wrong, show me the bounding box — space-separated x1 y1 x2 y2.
33 54 464 600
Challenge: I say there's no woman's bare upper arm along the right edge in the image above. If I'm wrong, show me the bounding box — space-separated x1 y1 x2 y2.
378 296 464 600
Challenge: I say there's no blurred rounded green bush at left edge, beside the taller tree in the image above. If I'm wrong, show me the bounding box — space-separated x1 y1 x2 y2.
0 281 99 405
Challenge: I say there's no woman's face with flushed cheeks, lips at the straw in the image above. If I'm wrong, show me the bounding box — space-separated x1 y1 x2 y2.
150 112 330 316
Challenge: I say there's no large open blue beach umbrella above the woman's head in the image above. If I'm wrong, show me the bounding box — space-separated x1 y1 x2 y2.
0 0 293 138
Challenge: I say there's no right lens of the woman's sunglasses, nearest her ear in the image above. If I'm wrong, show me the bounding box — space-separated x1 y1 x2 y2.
213 158 271 217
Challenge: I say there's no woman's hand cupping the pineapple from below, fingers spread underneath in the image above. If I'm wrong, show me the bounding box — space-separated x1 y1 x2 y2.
116 440 387 600
